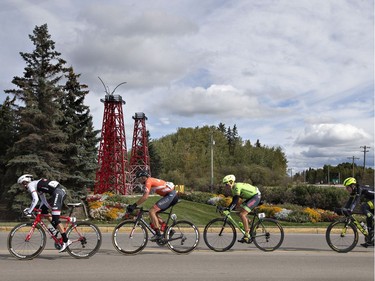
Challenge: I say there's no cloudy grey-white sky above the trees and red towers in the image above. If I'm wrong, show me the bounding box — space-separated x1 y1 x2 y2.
0 0 375 173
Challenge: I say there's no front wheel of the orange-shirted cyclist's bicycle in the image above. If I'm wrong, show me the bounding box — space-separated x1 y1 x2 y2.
112 220 148 255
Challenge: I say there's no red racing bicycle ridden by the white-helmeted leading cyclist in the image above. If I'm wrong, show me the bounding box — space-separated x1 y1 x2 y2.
7 203 102 260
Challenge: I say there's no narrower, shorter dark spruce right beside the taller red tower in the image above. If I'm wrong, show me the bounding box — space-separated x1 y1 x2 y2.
59 67 99 196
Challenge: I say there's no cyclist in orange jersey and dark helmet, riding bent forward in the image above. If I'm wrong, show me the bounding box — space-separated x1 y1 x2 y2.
127 170 178 241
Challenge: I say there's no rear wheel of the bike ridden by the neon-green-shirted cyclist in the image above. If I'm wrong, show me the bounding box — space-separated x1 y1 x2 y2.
252 218 284 252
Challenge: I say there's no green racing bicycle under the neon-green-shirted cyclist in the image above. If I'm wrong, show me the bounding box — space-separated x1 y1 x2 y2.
203 203 284 252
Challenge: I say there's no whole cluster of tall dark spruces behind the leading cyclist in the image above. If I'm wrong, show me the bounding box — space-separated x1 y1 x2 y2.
0 24 98 209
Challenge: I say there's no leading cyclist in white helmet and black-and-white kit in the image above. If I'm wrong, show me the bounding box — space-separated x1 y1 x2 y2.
17 174 72 250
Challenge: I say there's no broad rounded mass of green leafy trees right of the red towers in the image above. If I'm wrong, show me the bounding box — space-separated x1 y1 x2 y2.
151 123 287 187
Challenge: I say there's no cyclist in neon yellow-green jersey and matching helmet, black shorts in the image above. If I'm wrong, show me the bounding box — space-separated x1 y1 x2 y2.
223 175 261 243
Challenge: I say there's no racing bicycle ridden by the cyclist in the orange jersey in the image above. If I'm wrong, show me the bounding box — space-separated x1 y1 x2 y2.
112 201 199 255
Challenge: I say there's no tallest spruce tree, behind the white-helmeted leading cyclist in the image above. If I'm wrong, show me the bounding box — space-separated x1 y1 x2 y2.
4 24 67 208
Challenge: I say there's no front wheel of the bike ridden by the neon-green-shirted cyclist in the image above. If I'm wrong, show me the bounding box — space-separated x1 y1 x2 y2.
203 218 237 252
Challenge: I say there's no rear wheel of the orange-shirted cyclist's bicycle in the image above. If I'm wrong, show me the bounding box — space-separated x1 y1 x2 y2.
164 221 199 254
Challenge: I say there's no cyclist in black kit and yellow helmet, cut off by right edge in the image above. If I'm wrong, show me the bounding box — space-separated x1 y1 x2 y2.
343 177 374 248
